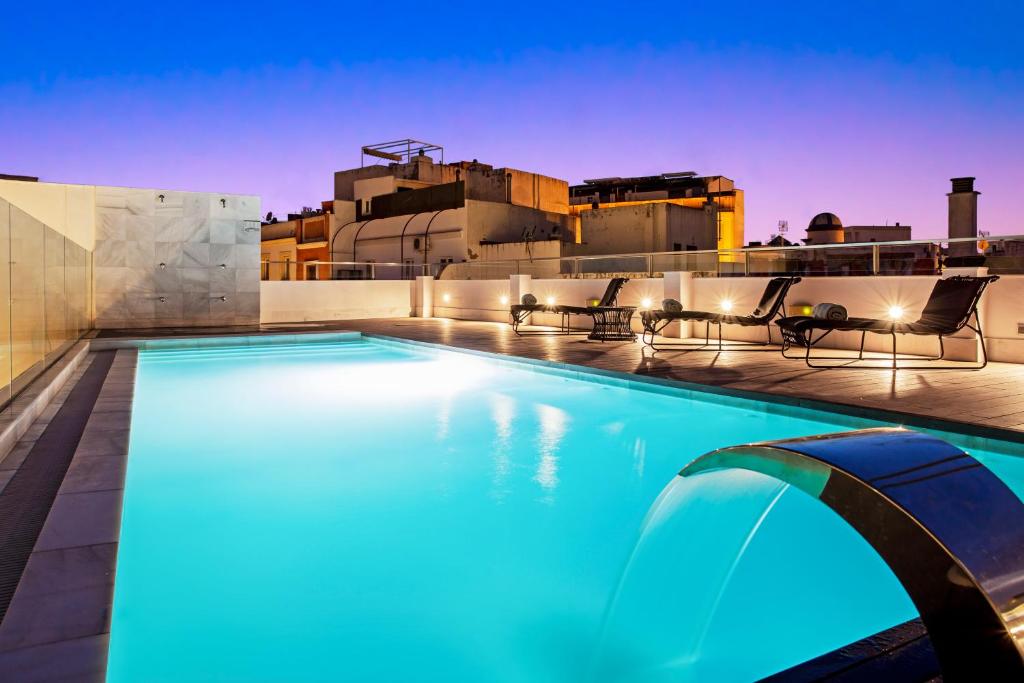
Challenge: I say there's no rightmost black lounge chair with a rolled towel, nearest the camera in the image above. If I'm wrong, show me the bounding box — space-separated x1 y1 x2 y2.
778 275 999 370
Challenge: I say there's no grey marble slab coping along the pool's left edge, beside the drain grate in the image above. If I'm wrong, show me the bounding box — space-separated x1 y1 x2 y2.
0 348 138 681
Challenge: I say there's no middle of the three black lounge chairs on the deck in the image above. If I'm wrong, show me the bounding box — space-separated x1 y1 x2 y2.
640 278 800 351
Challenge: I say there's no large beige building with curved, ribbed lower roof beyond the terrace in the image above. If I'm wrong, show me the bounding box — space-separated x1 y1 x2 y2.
327 155 577 278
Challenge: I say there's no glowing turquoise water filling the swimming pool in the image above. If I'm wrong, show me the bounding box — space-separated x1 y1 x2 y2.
108 341 1024 682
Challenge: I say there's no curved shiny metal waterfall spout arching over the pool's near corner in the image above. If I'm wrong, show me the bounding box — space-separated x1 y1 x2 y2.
679 429 1024 680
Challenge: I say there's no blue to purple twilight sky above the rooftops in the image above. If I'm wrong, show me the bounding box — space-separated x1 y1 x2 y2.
0 0 1024 240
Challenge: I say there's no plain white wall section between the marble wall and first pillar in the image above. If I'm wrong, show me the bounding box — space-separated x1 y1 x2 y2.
260 280 413 323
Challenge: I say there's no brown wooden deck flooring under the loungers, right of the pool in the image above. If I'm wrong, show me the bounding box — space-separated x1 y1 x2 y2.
331 318 1024 440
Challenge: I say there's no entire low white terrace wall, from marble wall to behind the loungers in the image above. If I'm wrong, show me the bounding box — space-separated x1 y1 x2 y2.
253 273 1024 362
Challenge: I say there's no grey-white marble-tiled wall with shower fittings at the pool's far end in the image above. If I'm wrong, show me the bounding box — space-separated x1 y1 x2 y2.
93 187 260 328
